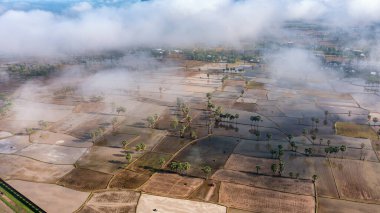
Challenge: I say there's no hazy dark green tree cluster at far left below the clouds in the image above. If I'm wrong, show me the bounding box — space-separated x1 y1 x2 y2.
8 64 60 77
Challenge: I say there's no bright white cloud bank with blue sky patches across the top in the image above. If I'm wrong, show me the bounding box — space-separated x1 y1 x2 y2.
0 0 380 56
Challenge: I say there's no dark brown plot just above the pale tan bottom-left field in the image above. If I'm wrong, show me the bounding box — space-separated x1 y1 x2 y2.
58 168 112 191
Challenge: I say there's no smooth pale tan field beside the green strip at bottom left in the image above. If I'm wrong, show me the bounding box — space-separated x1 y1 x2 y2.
8 180 90 213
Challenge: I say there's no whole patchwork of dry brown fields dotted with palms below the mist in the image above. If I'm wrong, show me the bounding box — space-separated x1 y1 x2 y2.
0 59 380 213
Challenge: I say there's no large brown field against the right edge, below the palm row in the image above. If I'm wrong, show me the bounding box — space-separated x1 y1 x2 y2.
331 159 380 203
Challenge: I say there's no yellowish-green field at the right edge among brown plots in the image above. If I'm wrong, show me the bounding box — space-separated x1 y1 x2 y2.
335 122 378 140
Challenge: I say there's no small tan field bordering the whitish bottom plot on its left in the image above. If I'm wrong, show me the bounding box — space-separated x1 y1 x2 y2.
79 190 140 213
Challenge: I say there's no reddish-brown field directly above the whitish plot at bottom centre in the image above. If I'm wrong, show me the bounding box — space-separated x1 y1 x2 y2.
141 173 203 198
